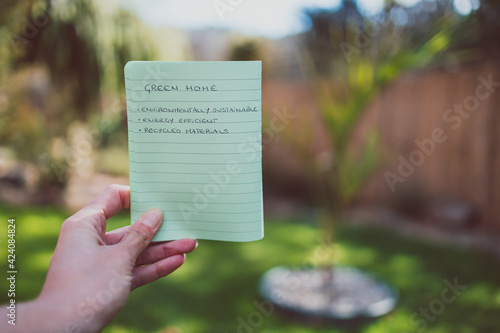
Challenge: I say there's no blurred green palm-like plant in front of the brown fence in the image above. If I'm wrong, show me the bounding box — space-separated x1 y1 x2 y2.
286 13 456 265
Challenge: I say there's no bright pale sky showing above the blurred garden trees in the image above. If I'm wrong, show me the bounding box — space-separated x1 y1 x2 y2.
120 0 479 38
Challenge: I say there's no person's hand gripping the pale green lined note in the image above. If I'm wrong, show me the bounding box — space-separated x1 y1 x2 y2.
9 185 197 332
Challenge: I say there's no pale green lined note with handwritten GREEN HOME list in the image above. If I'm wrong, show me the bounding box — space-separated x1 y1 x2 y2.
125 61 264 242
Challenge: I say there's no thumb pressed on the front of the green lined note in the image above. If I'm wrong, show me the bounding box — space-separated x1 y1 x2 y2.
120 208 163 262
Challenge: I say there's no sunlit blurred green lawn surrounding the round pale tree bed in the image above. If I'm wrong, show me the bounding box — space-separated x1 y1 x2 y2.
0 202 500 333
